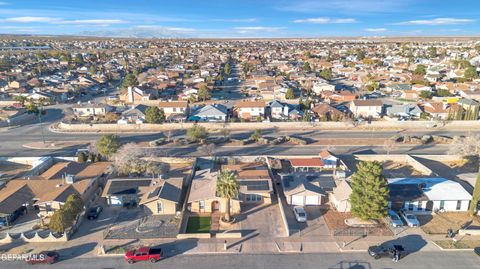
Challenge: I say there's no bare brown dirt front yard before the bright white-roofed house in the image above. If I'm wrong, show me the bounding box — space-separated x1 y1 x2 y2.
417 212 480 234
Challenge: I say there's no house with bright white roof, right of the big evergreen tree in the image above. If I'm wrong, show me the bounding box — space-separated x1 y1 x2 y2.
388 178 472 212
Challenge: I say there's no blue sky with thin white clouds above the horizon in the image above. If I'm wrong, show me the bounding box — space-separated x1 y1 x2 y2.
0 0 480 37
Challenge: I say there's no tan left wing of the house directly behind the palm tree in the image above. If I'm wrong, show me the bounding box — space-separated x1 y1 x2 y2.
187 169 240 214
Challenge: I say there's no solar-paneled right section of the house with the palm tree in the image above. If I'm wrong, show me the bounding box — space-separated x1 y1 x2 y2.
222 163 273 204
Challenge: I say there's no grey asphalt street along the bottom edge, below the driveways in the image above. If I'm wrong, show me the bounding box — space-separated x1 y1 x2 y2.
0 252 480 269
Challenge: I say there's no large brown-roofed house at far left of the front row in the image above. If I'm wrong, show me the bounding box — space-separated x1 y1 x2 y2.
0 162 111 219
